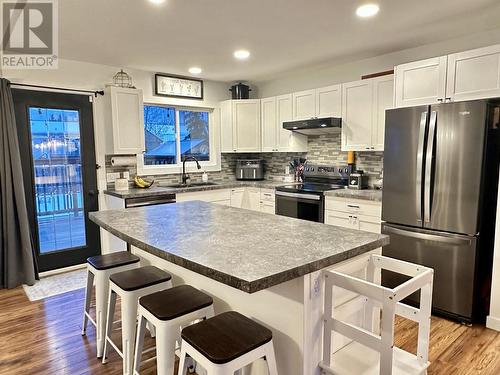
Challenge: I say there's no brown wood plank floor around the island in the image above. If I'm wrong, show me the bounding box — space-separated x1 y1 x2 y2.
0 288 500 375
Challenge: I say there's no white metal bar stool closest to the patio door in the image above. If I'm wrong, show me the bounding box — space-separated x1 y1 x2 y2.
82 251 140 358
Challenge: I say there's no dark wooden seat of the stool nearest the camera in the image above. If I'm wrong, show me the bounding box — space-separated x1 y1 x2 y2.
182 311 273 364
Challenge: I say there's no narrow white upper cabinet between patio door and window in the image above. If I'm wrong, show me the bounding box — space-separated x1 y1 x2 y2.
105 87 145 154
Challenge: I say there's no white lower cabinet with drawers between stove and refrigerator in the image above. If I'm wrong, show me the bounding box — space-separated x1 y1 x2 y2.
325 197 382 233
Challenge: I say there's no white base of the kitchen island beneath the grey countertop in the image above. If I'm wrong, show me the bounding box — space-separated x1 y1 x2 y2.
132 247 381 375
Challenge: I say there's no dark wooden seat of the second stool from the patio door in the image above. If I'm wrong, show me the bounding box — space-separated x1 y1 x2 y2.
109 266 172 292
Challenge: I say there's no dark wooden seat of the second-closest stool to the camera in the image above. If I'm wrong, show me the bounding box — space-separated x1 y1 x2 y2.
139 285 214 320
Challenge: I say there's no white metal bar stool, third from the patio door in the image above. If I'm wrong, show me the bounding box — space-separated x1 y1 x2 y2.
134 285 214 375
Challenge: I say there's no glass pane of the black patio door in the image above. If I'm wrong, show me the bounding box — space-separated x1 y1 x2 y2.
29 107 86 253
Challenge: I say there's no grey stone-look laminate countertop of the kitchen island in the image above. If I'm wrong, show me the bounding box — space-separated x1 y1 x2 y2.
90 201 389 293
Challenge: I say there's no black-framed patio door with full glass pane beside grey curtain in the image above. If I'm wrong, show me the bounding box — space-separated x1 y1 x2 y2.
13 90 100 271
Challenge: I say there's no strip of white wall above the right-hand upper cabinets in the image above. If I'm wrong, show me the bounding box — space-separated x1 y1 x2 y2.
256 28 500 98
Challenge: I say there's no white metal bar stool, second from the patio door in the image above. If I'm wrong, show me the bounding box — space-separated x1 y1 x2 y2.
102 266 172 375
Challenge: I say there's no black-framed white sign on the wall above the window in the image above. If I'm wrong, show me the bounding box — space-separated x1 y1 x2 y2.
155 73 203 100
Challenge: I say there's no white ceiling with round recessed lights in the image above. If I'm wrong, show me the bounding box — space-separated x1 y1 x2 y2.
59 0 500 81
